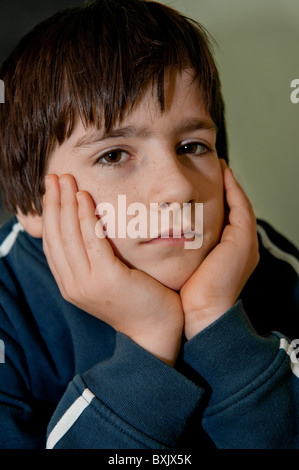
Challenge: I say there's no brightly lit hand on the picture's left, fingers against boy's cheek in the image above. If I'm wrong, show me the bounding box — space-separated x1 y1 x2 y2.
43 175 184 365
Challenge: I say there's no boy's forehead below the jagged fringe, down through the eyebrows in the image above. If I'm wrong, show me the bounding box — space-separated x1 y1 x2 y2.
70 70 216 149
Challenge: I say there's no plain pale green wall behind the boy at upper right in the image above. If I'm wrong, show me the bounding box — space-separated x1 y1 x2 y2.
162 0 299 246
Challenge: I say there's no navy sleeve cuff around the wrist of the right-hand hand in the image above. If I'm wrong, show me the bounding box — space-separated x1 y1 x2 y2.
184 300 279 405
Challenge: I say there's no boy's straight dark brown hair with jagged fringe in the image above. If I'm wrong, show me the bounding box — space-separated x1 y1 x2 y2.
0 0 227 215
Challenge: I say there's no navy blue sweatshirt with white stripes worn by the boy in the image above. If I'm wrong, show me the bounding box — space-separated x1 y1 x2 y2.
0 218 299 449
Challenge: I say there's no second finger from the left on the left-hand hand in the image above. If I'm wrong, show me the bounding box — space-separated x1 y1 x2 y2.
59 175 90 279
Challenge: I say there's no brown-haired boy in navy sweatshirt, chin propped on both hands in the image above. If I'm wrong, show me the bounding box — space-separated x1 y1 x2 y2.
0 0 299 449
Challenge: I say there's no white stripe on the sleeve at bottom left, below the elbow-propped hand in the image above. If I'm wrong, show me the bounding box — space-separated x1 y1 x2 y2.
46 388 95 449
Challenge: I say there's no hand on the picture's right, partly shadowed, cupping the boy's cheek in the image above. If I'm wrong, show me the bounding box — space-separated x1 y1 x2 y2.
180 159 259 339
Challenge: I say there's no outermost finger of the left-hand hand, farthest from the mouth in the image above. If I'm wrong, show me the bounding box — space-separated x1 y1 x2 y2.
43 175 70 286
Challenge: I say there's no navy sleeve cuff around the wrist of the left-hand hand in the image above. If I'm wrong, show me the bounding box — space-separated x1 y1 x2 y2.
82 333 204 447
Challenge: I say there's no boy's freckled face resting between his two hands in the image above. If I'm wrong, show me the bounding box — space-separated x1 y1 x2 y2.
47 71 224 290
